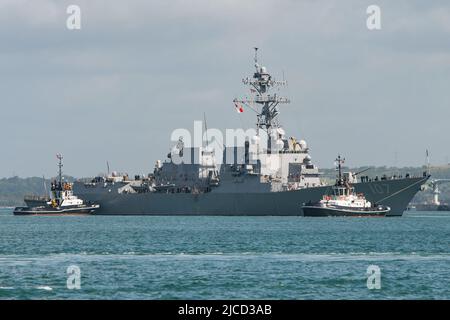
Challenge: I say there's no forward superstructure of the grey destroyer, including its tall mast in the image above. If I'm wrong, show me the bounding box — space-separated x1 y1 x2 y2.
234 48 322 191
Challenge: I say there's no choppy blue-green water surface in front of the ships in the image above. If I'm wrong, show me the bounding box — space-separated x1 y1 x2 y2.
0 209 450 299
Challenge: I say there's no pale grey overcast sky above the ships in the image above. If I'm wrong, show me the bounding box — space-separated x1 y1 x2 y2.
0 0 450 177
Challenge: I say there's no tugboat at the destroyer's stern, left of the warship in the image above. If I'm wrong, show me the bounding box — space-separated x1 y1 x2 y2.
14 154 100 215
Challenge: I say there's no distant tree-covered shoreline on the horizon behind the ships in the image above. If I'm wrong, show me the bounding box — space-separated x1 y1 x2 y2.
0 166 450 207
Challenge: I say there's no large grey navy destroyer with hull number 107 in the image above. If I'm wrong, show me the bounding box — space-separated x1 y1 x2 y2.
74 48 429 216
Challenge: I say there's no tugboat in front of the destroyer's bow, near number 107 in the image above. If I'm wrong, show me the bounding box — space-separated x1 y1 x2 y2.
302 156 391 217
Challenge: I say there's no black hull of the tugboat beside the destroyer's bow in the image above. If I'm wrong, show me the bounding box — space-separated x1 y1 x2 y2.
302 206 390 217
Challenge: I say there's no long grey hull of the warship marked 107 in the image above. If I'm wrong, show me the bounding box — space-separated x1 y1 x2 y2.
74 177 428 216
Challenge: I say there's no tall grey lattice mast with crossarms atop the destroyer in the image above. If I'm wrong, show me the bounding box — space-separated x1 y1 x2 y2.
233 48 290 153
